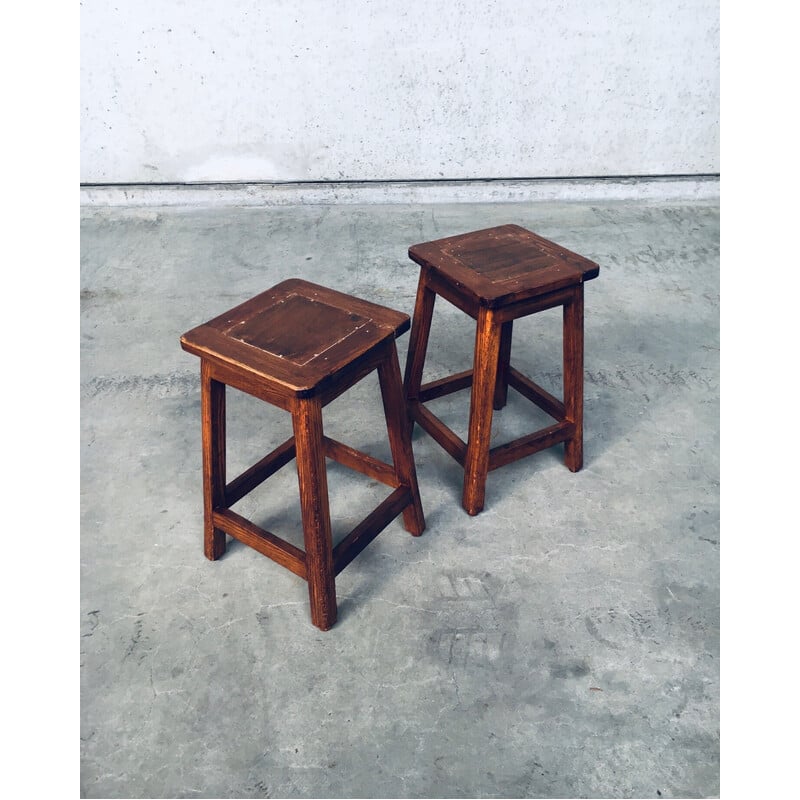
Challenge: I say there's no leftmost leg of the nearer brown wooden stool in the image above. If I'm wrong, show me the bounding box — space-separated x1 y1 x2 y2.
200 359 226 561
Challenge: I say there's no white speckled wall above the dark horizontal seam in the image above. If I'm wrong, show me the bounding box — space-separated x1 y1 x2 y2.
80 0 719 183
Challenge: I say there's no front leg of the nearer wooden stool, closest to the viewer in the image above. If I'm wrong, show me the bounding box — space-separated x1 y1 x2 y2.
292 397 336 631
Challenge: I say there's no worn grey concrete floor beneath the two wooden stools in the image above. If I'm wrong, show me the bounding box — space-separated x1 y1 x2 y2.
81 197 720 798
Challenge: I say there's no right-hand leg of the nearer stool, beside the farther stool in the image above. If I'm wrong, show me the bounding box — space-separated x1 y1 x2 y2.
378 341 425 536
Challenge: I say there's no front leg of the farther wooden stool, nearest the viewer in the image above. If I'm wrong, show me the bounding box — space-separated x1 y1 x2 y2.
461 308 501 516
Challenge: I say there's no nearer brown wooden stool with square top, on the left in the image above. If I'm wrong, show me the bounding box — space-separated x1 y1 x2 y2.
181 279 425 630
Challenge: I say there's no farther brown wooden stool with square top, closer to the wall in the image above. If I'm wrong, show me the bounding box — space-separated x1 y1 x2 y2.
405 225 600 515
